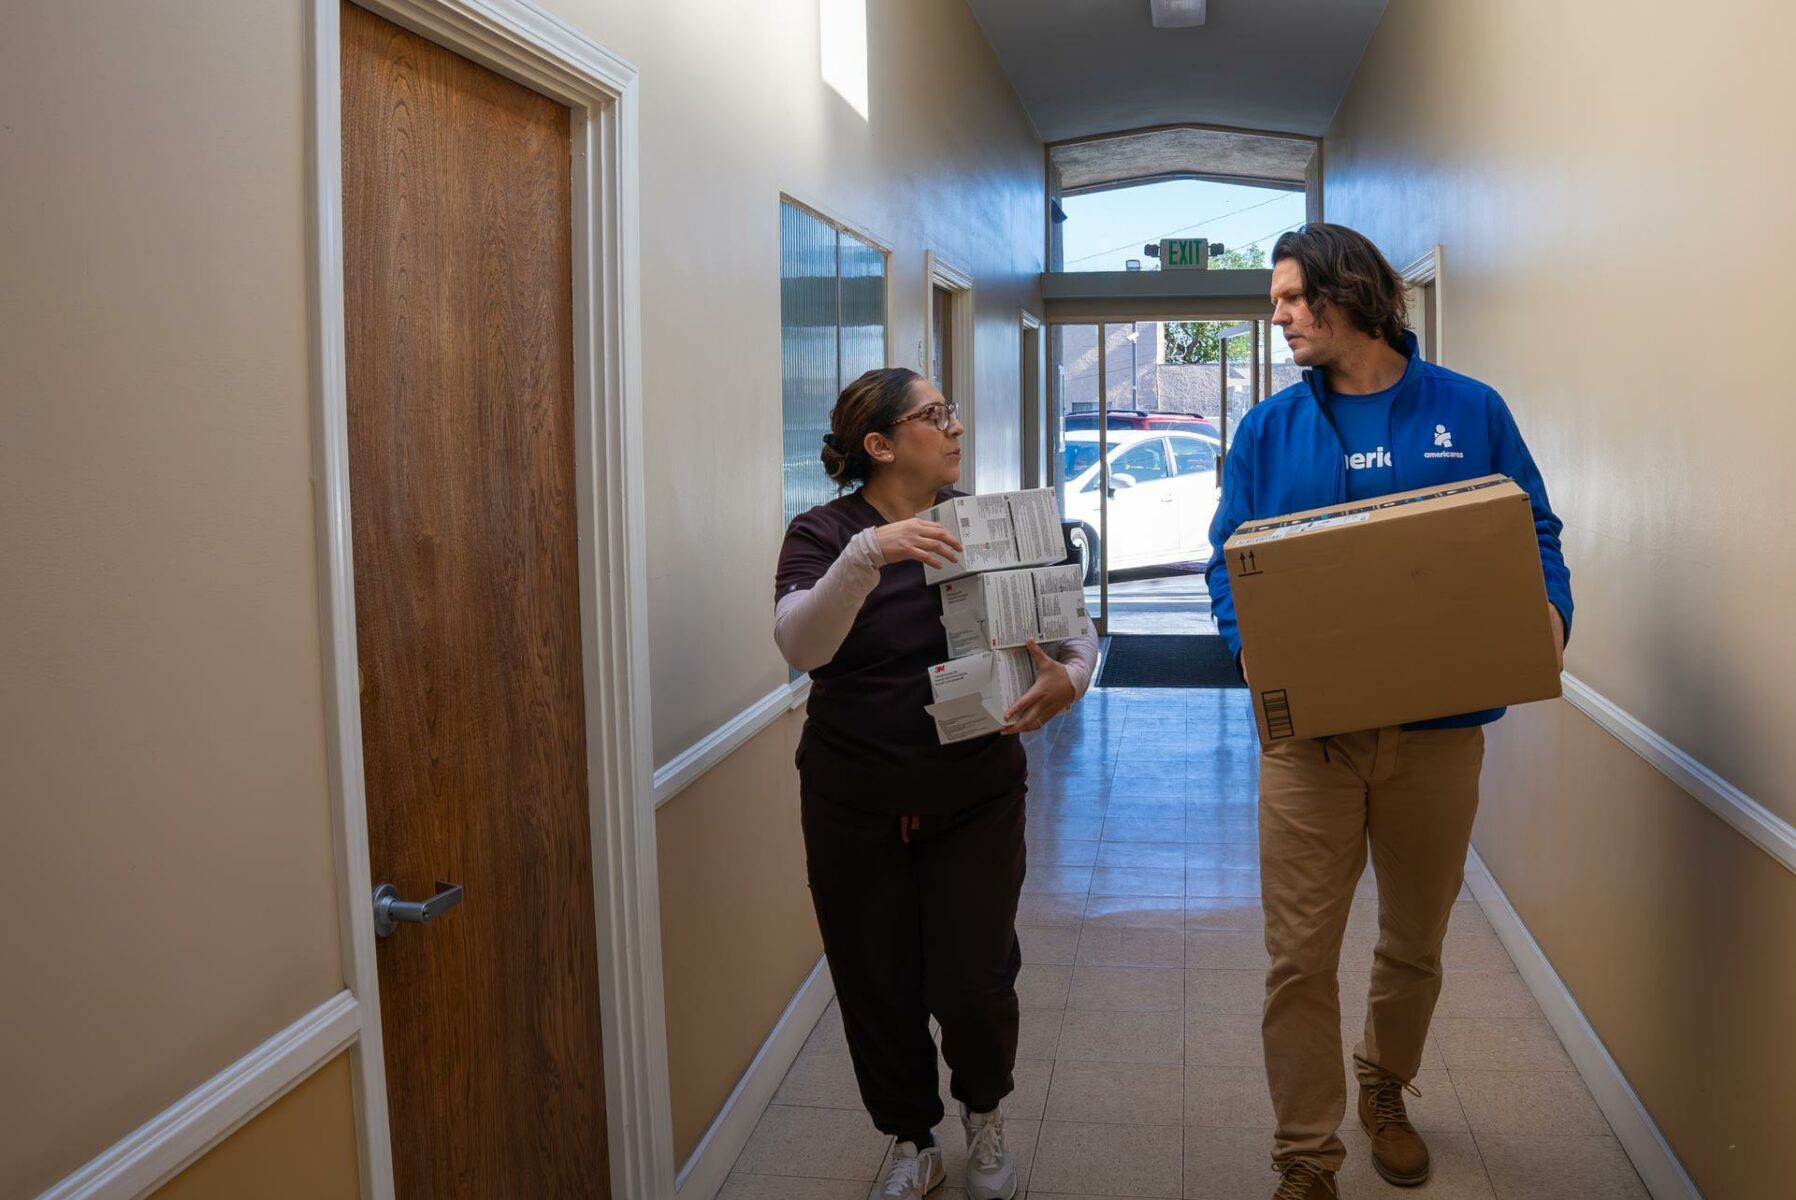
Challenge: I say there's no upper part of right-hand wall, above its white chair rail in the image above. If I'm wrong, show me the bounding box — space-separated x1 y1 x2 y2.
1324 0 1796 819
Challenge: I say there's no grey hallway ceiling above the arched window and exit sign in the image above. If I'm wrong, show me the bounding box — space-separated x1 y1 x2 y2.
966 0 1385 142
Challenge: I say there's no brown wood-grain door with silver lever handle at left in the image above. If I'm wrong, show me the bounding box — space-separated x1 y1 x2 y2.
341 4 609 1200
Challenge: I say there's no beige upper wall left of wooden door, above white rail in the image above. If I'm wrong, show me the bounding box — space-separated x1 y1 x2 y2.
0 0 343 1196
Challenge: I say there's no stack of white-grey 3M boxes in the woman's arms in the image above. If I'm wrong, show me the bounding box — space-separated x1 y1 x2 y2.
920 487 1090 746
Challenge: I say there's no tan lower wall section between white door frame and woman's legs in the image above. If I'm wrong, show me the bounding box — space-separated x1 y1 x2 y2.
657 713 823 1162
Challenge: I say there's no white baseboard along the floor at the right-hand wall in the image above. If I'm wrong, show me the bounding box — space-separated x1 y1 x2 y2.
1466 850 1703 1200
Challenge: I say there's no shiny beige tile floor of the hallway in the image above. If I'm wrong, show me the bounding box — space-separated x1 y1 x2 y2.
722 690 1647 1200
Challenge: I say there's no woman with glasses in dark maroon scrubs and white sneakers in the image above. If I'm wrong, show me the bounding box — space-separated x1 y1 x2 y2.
774 368 1097 1200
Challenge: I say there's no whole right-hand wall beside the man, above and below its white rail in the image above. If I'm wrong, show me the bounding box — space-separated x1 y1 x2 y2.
1327 0 1796 1196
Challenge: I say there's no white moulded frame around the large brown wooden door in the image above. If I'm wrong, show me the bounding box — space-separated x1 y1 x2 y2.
307 0 674 1200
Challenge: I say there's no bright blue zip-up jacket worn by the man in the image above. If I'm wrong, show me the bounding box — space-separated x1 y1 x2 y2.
1203 334 1572 728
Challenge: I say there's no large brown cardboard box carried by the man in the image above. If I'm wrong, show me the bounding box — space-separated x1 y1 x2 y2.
1225 476 1559 744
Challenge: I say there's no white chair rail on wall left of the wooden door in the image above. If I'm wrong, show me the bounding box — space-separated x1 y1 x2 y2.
38 990 361 1200
